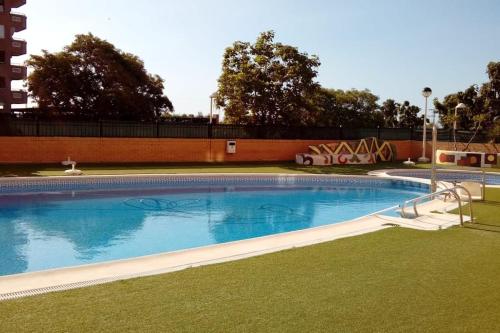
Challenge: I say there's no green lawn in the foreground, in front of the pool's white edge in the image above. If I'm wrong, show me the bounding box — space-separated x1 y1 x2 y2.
0 189 500 332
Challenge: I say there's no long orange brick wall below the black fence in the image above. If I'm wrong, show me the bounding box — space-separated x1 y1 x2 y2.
0 137 500 163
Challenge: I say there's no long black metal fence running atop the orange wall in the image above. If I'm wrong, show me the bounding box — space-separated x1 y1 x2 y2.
0 119 488 142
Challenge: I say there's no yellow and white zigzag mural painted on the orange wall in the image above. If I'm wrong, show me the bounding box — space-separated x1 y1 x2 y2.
295 138 396 165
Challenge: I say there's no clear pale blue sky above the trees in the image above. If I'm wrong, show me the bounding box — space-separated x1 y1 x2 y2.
15 0 500 114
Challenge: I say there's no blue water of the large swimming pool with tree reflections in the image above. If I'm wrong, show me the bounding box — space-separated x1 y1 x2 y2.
0 183 425 275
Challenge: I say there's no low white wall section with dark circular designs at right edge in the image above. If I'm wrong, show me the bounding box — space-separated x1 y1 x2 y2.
436 150 500 168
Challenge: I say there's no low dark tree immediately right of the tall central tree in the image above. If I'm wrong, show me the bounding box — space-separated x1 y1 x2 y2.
313 88 384 128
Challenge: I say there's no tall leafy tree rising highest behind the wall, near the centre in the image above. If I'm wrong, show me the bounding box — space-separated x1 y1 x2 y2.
216 31 320 126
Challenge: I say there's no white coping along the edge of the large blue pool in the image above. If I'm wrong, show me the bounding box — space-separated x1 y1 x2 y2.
0 174 458 301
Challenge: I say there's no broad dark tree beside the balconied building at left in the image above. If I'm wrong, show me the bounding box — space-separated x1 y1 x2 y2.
27 34 173 121
